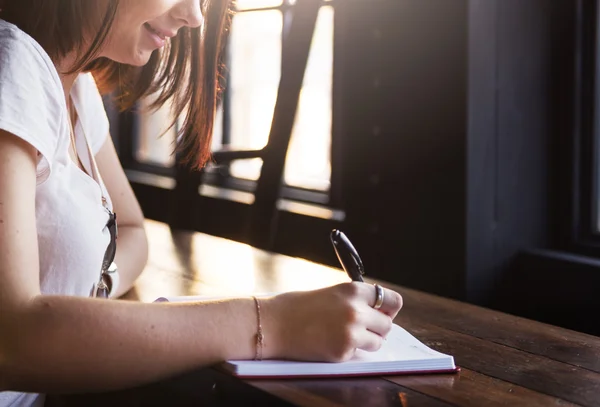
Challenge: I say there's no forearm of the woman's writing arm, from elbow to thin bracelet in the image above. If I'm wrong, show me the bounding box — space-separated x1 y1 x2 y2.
3 296 268 393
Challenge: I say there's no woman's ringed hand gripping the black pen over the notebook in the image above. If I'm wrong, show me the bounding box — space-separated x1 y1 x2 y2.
263 282 402 362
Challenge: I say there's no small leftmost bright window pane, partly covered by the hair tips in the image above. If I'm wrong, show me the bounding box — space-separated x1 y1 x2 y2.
135 99 176 167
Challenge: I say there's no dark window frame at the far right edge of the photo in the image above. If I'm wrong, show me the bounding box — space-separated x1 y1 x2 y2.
550 0 600 257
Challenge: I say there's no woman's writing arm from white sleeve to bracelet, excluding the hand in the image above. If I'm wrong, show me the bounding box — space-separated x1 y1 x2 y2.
0 133 276 392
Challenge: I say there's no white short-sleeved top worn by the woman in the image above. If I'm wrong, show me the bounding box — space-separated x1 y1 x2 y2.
0 20 112 407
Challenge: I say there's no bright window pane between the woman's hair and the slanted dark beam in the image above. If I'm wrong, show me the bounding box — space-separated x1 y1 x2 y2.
228 10 282 180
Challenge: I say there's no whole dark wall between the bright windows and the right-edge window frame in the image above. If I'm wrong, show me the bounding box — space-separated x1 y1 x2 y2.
336 0 553 304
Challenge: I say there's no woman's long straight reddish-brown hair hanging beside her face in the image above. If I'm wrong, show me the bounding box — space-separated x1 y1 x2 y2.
0 0 231 169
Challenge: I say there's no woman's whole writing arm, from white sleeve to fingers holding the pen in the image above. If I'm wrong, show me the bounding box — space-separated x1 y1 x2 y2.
0 132 401 393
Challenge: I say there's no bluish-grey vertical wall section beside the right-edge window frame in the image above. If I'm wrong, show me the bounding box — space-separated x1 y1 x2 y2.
467 0 558 304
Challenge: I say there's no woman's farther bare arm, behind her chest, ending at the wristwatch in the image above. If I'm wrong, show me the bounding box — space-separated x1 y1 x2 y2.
96 136 148 297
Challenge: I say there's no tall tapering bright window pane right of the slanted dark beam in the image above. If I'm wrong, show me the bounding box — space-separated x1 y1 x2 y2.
284 6 333 191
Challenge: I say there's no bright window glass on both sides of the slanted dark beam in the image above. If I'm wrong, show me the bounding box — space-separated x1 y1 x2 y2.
229 0 333 191
